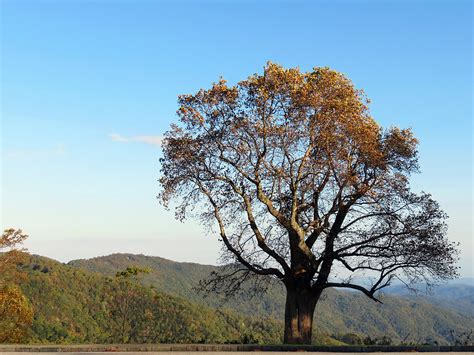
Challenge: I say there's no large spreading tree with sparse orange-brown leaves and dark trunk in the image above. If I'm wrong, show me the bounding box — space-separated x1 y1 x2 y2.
159 63 457 343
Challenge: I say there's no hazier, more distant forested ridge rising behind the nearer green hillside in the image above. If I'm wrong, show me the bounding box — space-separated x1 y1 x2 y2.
69 254 474 343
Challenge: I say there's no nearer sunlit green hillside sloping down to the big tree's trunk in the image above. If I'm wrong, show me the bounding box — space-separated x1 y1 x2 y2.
17 256 288 343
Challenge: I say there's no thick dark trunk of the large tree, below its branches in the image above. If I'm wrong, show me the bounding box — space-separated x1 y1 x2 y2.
284 285 319 344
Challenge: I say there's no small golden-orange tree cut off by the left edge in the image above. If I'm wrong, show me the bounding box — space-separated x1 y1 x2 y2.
0 228 33 343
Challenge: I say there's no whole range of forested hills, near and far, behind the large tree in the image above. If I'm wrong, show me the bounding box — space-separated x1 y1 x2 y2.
14 254 474 344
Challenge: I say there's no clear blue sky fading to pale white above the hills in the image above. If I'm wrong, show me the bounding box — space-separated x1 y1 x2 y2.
0 0 474 276
